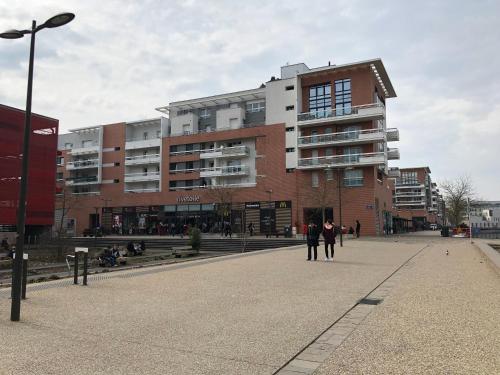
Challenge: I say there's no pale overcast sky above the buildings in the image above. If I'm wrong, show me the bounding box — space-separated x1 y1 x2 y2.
0 0 500 200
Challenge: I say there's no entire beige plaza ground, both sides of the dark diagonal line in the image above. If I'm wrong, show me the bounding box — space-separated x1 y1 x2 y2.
0 236 500 374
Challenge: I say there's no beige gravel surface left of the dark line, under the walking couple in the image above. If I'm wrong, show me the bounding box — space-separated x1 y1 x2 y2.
0 240 424 374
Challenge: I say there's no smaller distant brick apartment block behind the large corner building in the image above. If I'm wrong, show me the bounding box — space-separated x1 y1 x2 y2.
393 167 444 229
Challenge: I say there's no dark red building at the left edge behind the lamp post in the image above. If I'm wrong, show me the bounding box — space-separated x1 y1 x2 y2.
0 105 59 235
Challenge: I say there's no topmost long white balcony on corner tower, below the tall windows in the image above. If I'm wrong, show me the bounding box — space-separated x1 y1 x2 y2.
297 103 385 126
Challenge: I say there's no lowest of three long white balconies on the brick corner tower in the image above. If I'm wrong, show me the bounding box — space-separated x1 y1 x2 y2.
298 152 385 169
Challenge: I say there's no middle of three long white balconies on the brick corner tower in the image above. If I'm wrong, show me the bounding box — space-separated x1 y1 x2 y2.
298 129 385 148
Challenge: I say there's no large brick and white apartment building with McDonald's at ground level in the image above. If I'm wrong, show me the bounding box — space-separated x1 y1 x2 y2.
56 59 399 234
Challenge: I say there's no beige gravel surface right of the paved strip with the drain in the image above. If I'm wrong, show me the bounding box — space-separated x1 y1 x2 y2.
314 239 500 374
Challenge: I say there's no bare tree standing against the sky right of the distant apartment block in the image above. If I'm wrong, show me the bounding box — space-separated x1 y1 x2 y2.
440 176 474 227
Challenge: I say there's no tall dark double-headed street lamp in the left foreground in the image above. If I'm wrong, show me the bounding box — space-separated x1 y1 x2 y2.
0 13 75 322
